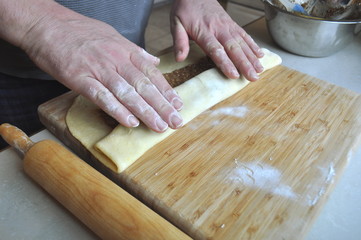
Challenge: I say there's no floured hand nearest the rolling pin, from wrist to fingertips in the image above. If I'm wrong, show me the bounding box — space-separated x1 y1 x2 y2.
22 6 182 132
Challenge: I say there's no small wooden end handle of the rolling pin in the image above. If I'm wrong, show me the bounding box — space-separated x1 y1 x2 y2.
0 123 34 155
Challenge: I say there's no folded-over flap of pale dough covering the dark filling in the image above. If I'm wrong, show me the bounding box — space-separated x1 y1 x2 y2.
94 49 282 173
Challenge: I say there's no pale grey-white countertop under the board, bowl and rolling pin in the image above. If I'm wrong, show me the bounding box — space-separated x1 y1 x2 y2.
0 19 361 240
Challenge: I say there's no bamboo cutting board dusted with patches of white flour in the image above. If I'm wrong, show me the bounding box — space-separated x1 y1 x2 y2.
39 66 361 239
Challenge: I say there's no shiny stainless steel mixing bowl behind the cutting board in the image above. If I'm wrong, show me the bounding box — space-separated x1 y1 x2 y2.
261 0 361 57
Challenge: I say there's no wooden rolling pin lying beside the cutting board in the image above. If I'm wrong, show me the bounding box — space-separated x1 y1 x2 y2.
0 123 190 240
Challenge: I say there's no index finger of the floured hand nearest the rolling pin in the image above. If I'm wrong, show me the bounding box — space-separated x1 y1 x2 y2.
131 54 183 111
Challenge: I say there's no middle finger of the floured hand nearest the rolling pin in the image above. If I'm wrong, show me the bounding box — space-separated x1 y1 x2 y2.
121 65 183 129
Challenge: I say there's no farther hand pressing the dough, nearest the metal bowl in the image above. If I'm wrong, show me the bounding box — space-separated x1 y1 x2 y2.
171 0 264 81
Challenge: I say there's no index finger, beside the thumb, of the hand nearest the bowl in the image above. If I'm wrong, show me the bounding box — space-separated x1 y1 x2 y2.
196 35 240 78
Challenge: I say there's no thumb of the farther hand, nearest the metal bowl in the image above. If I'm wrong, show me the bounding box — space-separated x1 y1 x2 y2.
171 17 189 62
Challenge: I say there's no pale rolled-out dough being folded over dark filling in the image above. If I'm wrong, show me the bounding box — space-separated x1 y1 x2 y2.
66 46 282 172
